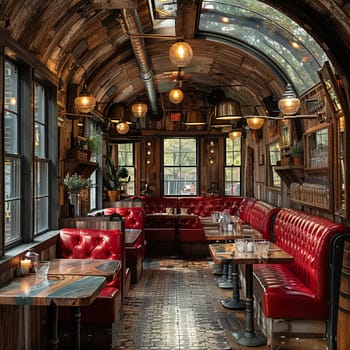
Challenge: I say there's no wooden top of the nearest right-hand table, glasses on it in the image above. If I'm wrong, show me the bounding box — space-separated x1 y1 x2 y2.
209 242 293 264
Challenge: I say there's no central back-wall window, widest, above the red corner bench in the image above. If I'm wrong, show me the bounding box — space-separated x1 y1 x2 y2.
163 138 198 196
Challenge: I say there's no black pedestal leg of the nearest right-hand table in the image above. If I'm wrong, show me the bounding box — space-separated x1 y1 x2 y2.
233 264 267 346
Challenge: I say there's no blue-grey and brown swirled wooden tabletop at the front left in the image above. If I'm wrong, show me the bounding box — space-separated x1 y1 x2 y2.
0 274 106 306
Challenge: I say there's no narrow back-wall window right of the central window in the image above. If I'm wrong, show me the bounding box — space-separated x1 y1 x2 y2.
225 137 242 196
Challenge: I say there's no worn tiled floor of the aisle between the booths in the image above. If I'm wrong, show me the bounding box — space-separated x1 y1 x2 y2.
113 258 326 350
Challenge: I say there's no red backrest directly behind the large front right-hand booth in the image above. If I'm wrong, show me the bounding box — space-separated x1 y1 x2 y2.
246 200 280 241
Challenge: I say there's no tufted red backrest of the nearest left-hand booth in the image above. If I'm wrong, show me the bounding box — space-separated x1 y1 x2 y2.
56 228 125 287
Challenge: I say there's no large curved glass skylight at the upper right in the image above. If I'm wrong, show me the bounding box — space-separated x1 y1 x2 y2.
199 0 328 94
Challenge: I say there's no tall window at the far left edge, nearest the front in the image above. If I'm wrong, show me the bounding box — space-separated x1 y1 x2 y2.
4 60 22 244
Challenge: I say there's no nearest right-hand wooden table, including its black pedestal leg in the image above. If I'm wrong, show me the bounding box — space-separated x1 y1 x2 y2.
209 243 293 346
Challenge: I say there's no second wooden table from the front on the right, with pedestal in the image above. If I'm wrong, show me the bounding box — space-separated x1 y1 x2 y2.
204 226 262 310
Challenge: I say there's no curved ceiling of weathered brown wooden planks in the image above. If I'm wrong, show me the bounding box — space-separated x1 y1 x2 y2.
0 0 350 120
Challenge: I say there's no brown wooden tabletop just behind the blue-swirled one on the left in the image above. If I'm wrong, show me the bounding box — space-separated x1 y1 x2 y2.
49 259 122 280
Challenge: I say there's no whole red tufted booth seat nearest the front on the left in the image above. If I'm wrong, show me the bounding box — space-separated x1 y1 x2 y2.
56 228 125 323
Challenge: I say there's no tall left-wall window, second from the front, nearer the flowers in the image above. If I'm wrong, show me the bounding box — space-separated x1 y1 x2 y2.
34 82 49 234
